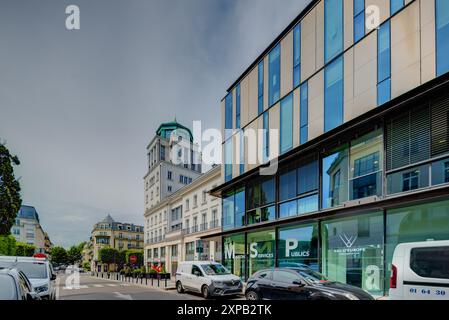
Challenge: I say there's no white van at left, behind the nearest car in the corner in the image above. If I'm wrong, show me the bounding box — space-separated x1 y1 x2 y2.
0 256 56 300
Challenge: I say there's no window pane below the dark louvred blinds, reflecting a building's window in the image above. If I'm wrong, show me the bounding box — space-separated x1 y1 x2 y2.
387 165 429 194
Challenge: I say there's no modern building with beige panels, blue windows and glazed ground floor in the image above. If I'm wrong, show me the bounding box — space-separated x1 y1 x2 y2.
211 0 449 296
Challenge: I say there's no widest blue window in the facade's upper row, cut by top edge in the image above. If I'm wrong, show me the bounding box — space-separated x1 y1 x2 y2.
324 0 343 63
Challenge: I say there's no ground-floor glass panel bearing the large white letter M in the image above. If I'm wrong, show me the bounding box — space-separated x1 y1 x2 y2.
223 234 246 280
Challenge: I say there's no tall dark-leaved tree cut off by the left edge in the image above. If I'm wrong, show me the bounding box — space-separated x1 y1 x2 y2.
0 143 22 235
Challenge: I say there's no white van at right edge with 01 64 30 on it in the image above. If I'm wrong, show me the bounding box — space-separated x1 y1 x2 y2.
389 241 449 300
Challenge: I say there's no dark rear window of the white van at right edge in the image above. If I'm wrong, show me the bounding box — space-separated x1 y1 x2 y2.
410 247 449 279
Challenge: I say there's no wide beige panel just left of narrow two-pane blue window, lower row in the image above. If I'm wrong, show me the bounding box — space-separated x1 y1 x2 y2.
348 32 377 119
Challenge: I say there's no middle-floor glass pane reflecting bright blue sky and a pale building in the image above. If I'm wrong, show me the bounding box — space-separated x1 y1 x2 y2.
322 145 349 209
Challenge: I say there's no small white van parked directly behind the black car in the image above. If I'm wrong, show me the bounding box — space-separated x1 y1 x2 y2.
176 261 243 299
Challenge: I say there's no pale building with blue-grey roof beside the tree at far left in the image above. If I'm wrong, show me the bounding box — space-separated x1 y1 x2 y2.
11 206 47 253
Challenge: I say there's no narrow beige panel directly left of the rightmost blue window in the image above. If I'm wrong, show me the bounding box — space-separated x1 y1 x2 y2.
420 0 436 83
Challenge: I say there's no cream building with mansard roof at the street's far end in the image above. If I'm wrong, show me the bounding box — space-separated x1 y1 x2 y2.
91 215 143 271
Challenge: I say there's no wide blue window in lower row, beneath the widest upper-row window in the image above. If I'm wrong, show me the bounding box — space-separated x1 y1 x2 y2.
324 56 343 132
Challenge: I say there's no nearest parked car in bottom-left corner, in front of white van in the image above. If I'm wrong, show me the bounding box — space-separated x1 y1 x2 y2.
0 268 40 300
